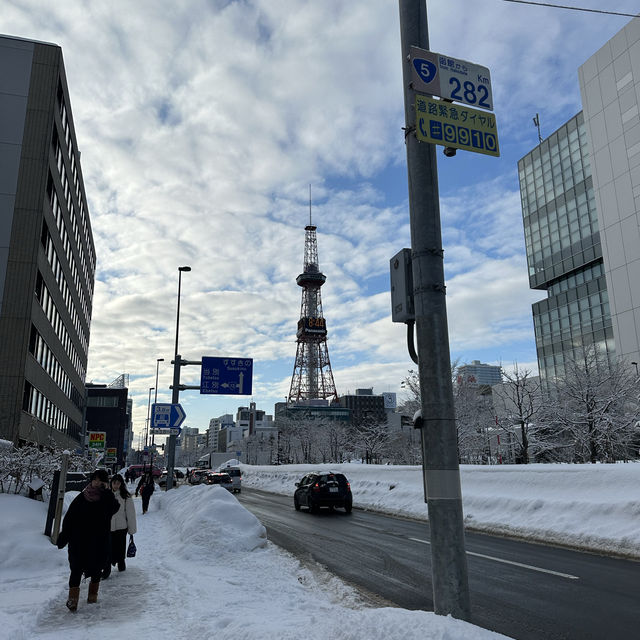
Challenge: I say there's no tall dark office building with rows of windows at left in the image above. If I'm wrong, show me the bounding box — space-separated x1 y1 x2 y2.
0 36 95 448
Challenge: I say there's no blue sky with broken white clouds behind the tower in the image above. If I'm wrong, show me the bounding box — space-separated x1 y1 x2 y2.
0 0 637 446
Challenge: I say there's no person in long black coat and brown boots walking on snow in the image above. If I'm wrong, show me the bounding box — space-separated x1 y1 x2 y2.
56 469 120 611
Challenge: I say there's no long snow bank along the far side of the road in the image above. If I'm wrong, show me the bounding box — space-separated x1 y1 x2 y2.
241 463 640 558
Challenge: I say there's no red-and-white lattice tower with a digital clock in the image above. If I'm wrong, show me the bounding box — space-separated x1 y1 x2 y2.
288 195 338 404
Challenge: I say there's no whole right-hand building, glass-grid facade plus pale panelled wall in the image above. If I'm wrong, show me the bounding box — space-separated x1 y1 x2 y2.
518 18 640 380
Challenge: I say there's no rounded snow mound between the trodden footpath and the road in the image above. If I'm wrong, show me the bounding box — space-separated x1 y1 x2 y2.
159 485 267 557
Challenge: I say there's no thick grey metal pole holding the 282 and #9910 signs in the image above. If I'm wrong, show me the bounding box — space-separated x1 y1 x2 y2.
399 0 471 620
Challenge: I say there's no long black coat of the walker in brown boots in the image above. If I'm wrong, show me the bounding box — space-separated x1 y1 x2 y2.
56 489 120 575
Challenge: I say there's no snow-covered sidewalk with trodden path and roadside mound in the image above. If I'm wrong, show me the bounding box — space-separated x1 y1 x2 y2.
0 486 504 640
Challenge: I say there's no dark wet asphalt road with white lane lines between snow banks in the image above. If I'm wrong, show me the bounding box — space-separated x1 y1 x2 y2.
239 488 640 640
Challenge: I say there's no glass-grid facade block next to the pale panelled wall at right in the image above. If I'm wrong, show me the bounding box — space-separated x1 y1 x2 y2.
518 112 615 380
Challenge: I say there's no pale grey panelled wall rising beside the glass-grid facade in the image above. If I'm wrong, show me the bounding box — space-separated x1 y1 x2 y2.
578 18 640 362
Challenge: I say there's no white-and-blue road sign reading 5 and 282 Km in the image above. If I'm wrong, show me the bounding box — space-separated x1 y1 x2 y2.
410 47 493 111
